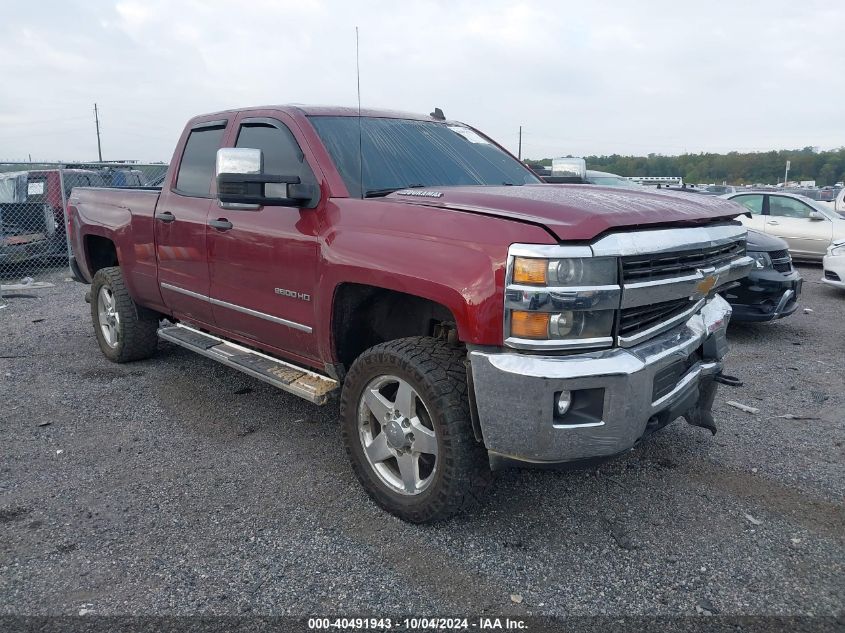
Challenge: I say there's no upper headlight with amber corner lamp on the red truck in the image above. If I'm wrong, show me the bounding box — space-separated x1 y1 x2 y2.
513 257 616 287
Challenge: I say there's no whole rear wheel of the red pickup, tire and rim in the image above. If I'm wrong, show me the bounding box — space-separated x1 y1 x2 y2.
91 266 158 363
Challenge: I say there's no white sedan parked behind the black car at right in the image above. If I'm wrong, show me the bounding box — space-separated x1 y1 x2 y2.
722 191 845 261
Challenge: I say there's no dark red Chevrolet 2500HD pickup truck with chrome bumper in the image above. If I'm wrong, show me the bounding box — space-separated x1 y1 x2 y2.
68 106 751 522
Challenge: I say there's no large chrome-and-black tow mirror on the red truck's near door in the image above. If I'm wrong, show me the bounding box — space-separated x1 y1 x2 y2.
216 147 319 208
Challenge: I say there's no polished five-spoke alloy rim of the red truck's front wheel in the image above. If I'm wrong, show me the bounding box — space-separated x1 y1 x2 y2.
358 376 438 495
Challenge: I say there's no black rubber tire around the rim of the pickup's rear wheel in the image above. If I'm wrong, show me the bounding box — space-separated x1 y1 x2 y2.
91 266 159 363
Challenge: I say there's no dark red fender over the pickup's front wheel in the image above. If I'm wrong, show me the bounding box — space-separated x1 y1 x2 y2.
315 200 555 360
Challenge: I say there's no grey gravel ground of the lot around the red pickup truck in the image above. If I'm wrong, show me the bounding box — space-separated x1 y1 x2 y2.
0 266 845 616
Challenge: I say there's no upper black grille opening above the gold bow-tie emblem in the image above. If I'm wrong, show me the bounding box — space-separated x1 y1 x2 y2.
622 240 745 282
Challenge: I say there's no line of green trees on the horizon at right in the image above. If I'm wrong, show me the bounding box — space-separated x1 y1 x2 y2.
525 147 845 187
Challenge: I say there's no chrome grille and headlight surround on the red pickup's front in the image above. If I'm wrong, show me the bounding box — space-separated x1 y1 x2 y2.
503 223 754 351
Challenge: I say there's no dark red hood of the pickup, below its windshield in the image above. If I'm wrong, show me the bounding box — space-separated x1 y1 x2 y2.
383 184 746 240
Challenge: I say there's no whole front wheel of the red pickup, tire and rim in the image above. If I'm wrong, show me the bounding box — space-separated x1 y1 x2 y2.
340 337 492 523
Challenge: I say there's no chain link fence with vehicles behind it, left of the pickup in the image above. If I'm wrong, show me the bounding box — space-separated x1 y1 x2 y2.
0 162 167 286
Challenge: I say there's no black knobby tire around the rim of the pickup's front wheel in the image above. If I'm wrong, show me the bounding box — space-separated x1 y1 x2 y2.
340 337 493 523
